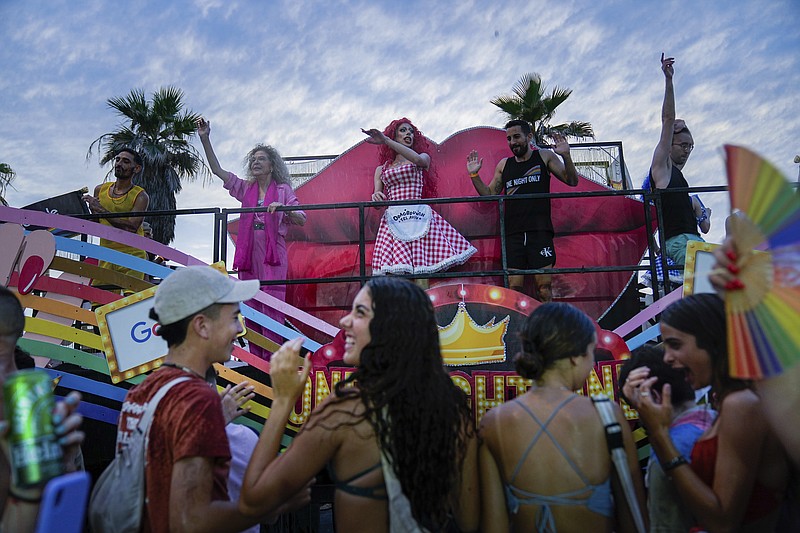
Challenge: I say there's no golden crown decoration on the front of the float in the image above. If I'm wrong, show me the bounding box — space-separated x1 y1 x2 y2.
439 302 510 366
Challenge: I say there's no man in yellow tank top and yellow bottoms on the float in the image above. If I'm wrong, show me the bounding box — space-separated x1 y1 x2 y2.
83 148 150 285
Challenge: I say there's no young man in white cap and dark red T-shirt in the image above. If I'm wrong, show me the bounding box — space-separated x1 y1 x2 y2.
117 266 268 532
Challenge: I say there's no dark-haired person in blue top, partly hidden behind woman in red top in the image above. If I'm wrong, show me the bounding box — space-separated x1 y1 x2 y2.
619 345 717 533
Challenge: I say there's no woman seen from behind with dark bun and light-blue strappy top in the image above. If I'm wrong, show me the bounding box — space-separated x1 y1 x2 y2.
480 303 644 532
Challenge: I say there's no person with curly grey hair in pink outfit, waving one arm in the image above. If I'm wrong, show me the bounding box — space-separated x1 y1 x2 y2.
197 118 306 359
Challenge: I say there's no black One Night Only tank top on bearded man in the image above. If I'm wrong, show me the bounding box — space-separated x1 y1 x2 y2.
502 150 553 236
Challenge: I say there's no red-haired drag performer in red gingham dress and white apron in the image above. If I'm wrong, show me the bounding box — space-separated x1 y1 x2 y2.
361 118 477 275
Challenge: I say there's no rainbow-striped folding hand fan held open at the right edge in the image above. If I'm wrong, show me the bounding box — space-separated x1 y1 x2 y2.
725 145 800 379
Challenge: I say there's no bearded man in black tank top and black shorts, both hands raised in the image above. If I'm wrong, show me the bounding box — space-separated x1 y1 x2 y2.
467 120 578 302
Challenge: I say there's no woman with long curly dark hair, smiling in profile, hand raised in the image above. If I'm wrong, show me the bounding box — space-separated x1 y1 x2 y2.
240 277 480 532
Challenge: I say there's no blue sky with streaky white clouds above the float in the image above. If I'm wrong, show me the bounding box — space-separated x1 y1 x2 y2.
0 0 800 259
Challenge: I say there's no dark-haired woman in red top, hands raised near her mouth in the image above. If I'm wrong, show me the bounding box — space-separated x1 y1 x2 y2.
624 294 789 531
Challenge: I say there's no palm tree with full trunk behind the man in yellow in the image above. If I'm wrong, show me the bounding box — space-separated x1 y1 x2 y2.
86 87 208 244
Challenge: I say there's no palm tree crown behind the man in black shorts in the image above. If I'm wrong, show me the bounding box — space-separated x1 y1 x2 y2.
491 72 594 146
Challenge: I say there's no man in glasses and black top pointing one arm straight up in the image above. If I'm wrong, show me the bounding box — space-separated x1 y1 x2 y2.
650 54 711 265
